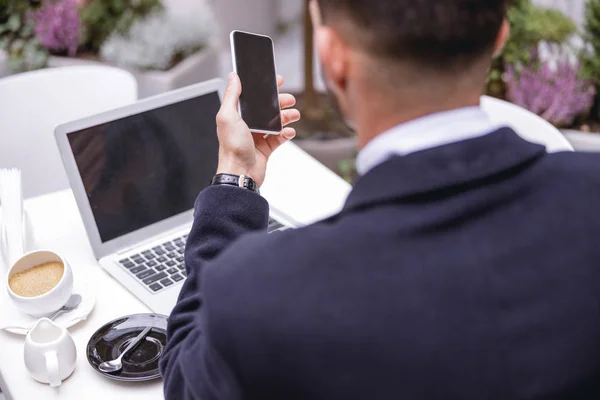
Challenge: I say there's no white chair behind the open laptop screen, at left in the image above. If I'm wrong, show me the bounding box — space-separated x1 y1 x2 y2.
0 66 137 198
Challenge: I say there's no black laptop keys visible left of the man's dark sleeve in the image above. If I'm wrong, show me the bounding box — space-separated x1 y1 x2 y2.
119 235 188 293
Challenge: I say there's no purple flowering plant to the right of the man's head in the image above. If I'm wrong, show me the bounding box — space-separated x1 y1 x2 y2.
505 48 596 127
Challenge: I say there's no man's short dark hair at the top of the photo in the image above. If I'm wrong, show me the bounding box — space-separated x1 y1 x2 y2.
318 0 507 71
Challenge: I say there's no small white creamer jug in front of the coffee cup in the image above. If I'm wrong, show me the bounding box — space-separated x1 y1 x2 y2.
25 318 77 387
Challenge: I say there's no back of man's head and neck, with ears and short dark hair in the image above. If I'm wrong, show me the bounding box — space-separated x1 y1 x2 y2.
311 0 511 141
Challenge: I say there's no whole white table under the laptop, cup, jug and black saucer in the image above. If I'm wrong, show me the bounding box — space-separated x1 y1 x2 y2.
0 145 350 400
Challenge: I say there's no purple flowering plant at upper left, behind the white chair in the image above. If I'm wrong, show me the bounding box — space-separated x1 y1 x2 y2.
34 0 81 56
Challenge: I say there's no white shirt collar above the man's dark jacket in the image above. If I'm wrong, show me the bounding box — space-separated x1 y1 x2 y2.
356 106 497 175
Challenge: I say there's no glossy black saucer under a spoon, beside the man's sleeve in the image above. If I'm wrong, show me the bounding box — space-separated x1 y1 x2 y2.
86 314 167 382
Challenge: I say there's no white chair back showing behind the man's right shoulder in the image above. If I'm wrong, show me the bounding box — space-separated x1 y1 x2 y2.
481 96 573 153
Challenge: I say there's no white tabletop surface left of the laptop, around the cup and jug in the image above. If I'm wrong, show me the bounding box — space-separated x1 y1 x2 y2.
0 190 163 400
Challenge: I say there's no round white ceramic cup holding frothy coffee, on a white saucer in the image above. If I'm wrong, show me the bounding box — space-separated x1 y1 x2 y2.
6 250 73 317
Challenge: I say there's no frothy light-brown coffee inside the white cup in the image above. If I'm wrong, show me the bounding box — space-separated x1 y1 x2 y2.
8 261 65 297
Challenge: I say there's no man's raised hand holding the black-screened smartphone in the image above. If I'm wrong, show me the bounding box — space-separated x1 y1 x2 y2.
217 73 300 186
